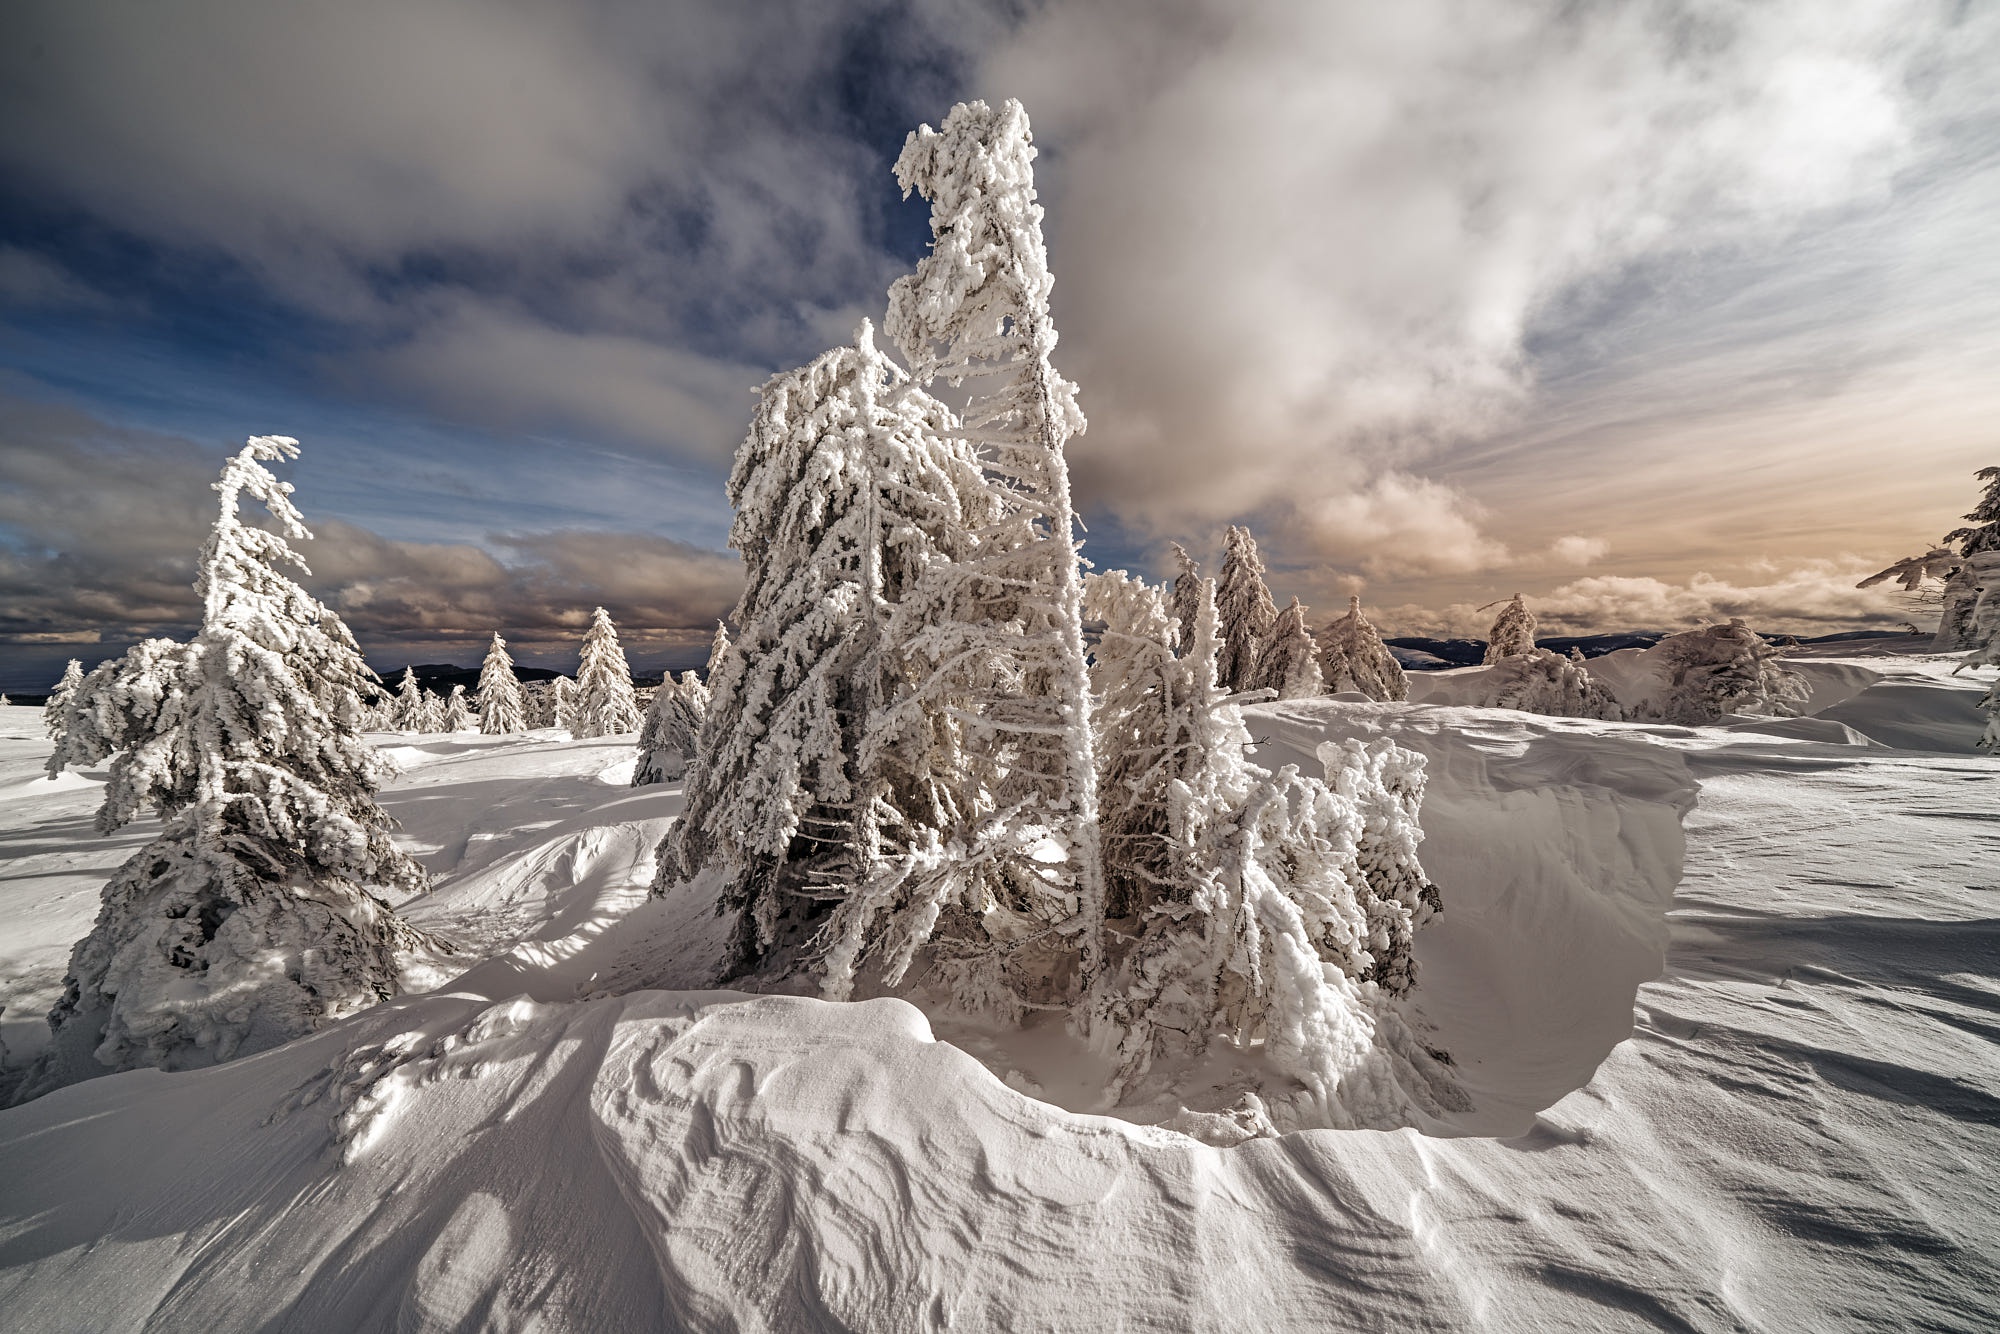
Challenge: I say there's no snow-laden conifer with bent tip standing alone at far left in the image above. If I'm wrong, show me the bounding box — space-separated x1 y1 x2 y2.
26 436 438 1094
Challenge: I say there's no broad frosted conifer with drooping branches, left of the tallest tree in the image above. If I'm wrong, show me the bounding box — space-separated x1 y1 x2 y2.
660 320 986 972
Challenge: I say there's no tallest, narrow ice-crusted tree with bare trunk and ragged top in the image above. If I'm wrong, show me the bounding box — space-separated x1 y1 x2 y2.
868 100 1104 1008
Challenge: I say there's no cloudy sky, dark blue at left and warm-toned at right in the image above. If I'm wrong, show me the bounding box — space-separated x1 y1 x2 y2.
0 0 2000 690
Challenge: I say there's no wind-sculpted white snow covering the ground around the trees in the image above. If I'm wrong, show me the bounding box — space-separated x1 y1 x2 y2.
0 660 2000 1332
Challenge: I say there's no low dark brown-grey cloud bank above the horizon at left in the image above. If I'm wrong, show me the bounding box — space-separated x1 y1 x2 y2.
0 396 742 660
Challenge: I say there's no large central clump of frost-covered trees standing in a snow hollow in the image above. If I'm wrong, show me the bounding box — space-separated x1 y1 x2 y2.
654 102 1458 1130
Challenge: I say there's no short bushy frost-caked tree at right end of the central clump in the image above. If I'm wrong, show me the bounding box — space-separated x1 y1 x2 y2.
1088 586 1462 1134
